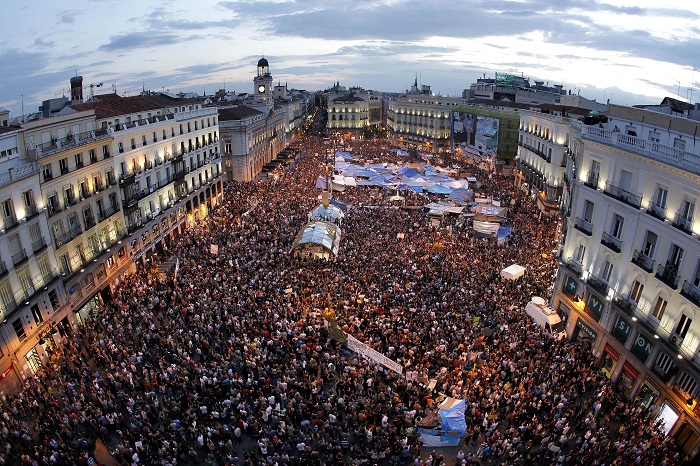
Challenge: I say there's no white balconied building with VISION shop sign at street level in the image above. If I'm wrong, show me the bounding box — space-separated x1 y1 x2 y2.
556 106 700 454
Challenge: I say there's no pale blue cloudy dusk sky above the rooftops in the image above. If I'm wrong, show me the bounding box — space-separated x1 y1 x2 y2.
0 0 700 116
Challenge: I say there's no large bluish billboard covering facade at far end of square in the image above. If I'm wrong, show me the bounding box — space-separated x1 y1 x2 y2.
451 112 499 160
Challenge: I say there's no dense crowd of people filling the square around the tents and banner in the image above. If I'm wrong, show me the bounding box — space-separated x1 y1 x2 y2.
0 131 683 466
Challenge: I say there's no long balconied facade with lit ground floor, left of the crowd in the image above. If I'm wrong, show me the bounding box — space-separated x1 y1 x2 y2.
0 90 223 390
